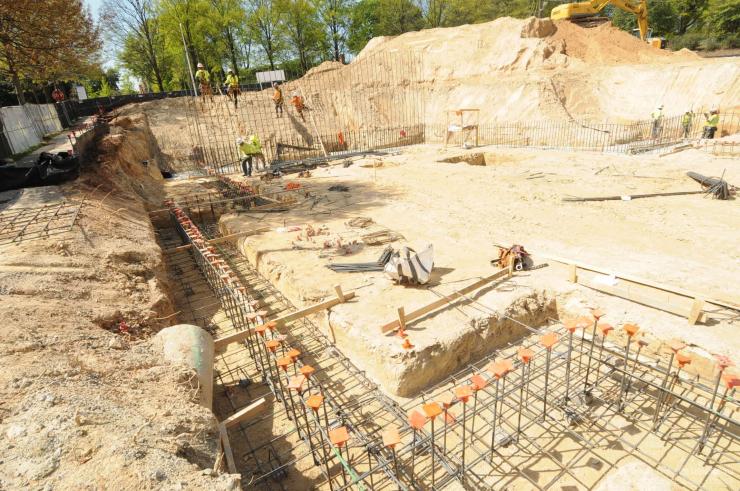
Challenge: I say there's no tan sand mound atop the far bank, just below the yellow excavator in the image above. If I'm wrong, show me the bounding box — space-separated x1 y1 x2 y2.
357 17 698 76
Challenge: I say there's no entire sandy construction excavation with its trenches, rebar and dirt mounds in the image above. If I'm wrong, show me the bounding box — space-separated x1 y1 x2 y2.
0 17 740 491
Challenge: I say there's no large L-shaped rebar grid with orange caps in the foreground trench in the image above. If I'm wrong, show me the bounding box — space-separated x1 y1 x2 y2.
155 201 740 489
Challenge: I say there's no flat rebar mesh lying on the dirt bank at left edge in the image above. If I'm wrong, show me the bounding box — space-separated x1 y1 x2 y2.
0 201 81 245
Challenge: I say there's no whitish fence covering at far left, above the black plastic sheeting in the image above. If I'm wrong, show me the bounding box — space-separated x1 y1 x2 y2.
0 104 62 153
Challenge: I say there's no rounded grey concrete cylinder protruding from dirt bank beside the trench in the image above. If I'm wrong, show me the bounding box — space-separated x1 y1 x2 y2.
152 324 213 409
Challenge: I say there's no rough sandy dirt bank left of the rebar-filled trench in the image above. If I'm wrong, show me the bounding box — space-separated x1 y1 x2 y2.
0 114 236 489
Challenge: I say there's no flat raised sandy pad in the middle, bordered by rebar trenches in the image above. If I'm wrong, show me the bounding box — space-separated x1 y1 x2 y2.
222 146 740 395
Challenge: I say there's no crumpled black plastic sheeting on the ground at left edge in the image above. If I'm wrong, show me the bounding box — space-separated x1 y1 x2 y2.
0 152 80 191
